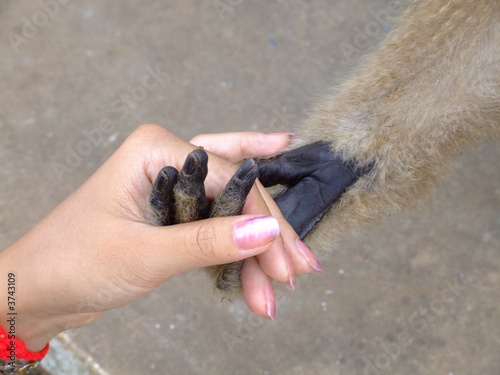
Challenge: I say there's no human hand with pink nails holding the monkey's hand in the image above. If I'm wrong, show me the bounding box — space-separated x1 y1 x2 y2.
0 125 320 351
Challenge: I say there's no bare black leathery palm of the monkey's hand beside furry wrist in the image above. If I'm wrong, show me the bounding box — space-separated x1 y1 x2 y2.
258 142 370 239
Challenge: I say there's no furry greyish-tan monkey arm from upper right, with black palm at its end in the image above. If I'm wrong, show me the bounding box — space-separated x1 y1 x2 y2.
261 0 500 249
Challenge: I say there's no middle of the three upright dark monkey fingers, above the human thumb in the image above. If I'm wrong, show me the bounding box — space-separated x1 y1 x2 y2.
174 149 209 223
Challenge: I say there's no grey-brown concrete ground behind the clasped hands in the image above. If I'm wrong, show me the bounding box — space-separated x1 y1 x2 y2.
0 0 500 375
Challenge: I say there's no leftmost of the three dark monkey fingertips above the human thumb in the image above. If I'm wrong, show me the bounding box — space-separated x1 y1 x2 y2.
149 167 179 225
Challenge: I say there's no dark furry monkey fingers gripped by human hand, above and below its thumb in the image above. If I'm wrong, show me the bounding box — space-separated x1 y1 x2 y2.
149 148 259 292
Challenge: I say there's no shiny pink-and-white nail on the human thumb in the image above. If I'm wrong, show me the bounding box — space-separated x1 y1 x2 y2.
233 216 280 250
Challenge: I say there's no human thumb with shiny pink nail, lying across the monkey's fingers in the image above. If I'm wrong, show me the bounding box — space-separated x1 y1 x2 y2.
148 215 280 276
